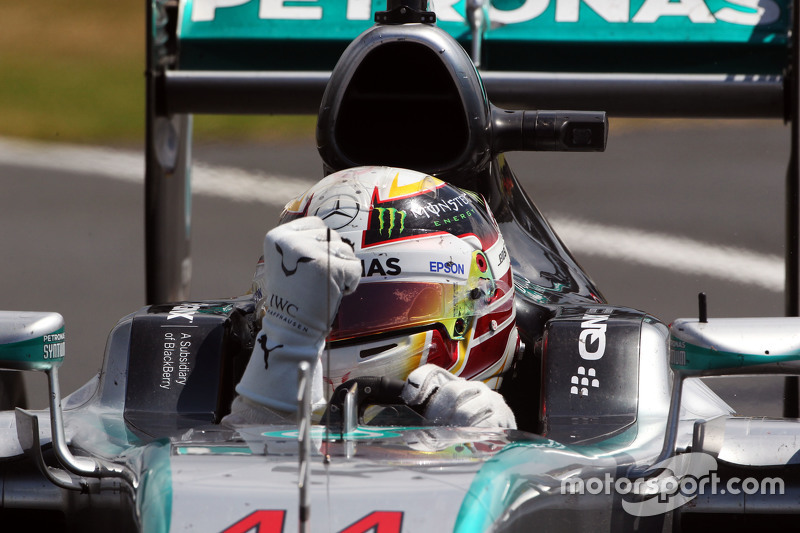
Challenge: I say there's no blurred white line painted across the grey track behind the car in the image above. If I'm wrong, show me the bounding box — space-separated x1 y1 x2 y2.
0 139 784 292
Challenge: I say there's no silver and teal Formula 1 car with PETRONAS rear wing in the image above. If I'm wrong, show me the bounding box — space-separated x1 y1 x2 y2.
0 0 800 533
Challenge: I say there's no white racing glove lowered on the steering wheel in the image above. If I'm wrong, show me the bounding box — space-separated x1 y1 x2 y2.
401 364 517 429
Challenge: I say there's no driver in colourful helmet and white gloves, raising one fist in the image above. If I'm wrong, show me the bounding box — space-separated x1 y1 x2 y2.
223 167 519 428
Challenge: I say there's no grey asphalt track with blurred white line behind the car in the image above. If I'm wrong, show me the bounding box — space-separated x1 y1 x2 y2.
0 121 789 415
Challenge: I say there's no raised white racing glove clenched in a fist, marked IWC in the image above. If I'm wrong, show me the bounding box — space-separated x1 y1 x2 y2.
234 217 361 413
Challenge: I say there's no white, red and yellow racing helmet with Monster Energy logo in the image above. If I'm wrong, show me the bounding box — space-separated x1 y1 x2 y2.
281 166 519 389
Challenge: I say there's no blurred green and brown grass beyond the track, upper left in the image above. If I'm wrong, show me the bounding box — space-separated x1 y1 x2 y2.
0 0 315 144
